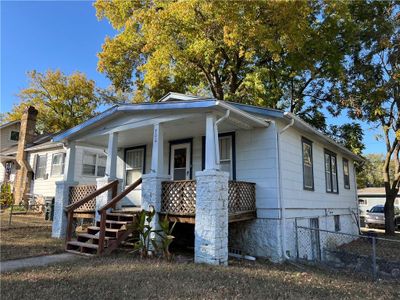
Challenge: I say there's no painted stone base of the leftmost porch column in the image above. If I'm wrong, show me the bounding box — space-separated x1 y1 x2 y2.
51 181 78 238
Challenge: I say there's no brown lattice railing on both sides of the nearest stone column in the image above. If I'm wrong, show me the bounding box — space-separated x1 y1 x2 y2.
161 180 256 216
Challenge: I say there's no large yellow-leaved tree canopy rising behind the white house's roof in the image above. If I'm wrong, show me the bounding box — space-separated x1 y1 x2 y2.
94 0 348 111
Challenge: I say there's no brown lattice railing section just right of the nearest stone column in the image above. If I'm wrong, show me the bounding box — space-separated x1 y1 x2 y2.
228 180 256 213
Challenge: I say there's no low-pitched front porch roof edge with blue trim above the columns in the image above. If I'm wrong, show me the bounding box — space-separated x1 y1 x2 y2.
53 99 269 142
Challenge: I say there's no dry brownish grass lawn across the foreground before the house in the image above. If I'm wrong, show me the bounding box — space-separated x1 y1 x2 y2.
1 253 400 299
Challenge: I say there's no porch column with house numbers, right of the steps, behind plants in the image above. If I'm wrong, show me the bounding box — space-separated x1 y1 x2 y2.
142 124 171 247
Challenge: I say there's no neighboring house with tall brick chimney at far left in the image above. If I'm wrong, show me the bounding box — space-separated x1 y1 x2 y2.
0 107 106 204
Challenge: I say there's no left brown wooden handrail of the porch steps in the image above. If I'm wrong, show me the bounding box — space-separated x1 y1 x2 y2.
65 180 118 242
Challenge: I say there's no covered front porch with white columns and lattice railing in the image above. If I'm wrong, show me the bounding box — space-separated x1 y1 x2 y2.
53 103 268 264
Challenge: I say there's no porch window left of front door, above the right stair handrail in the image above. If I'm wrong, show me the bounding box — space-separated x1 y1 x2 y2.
125 146 146 185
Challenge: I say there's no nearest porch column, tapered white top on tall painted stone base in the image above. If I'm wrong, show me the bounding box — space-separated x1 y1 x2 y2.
194 114 229 265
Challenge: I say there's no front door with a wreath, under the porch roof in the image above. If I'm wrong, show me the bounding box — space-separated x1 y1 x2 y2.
171 143 191 180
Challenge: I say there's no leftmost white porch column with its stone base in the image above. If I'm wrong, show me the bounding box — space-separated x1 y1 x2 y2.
51 142 78 238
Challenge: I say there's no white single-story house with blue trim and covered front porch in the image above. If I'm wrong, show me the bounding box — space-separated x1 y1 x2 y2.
53 93 360 264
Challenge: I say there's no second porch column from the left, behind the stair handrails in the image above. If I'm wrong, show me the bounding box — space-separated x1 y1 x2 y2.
96 132 118 221
